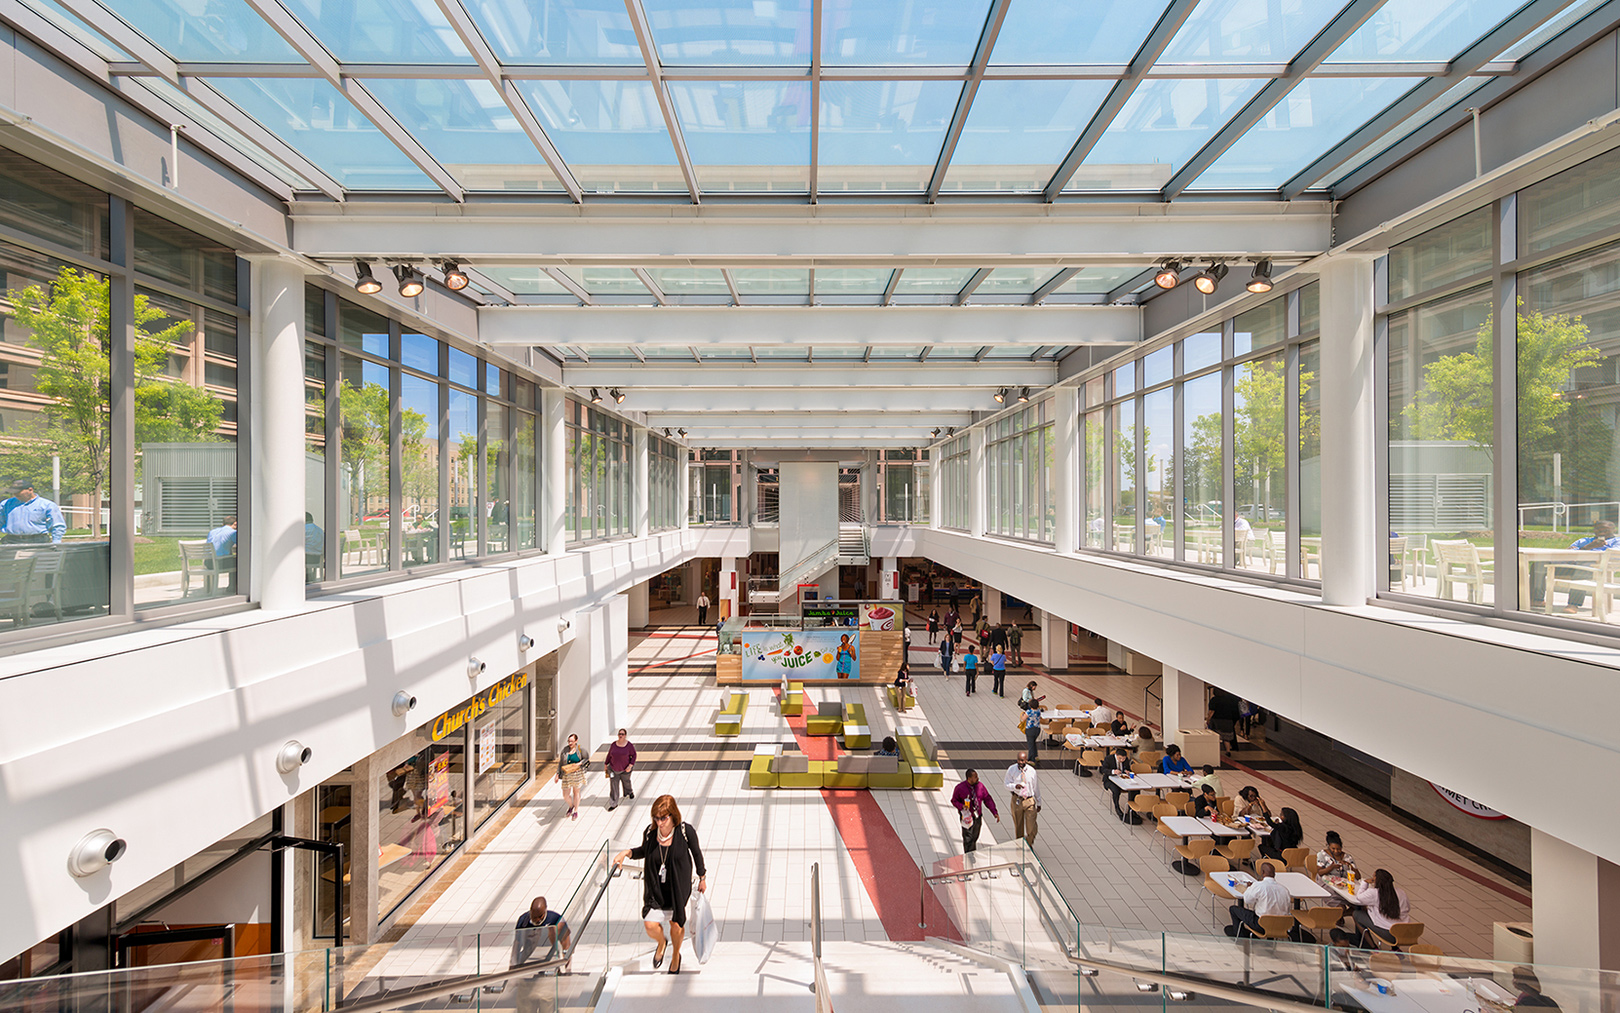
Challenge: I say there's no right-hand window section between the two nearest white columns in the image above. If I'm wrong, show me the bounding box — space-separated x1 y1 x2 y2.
1081 284 1320 579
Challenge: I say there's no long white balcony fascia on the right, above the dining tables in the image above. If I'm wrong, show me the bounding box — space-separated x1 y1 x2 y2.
919 530 1620 862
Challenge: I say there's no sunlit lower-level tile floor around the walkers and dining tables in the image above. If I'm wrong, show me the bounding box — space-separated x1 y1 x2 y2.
367 629 1529 972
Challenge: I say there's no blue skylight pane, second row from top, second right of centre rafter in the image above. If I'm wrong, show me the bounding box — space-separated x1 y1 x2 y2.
944 81 1113 191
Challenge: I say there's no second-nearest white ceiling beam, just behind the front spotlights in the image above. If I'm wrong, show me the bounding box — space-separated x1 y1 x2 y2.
478 305 1142 348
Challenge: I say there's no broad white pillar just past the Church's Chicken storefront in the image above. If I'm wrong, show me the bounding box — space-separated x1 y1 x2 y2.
557 595 630 752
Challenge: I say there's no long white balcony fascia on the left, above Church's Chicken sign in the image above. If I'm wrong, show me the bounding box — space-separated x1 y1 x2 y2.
0 532 695 956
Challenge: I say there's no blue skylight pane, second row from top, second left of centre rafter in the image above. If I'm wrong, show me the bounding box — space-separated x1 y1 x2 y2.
517 81 687 191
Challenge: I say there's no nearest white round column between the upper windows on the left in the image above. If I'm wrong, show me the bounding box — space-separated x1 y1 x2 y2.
240 258 306 611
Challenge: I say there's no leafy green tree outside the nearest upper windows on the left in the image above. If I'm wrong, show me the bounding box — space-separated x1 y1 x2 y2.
11 267 204 536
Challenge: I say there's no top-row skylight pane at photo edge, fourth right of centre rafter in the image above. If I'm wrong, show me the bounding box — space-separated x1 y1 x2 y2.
1327 0 1524 63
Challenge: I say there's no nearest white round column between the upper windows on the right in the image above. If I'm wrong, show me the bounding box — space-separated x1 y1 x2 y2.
1317 258 1377 605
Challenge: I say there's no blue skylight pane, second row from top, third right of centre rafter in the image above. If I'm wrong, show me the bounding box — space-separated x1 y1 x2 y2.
1064 78 1265 190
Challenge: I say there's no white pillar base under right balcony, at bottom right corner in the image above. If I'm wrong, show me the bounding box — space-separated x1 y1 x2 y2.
1529 827 1620 984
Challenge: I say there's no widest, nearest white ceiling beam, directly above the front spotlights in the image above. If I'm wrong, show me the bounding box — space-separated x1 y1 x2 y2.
293 199 1333 260
